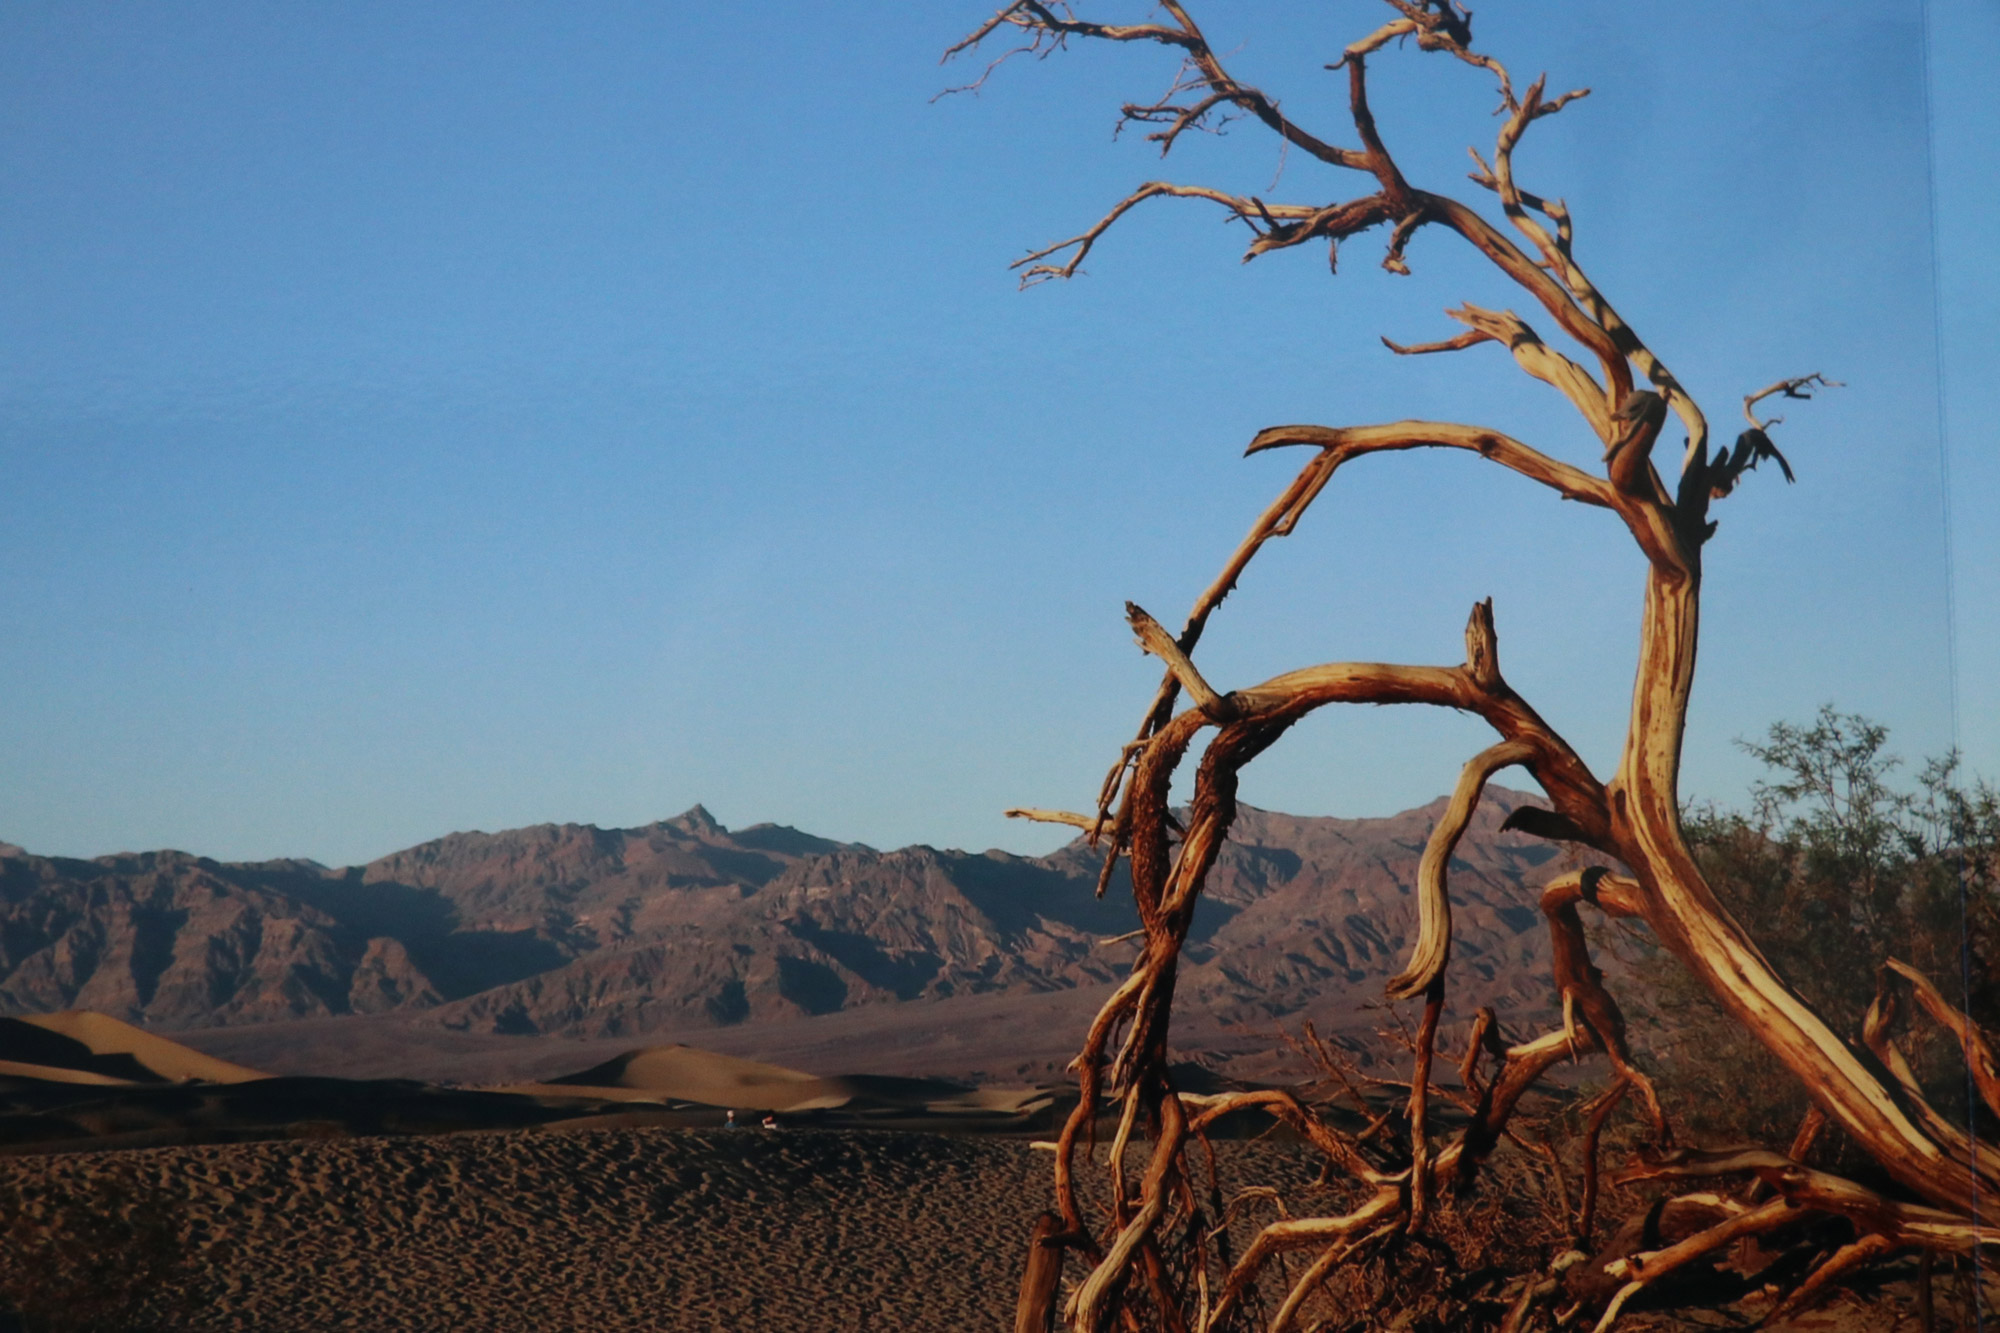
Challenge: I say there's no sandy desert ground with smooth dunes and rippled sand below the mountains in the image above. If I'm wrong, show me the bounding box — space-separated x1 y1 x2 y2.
0 1013 1954 1333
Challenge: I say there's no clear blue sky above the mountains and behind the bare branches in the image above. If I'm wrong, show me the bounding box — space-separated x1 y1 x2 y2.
0 0 2000 863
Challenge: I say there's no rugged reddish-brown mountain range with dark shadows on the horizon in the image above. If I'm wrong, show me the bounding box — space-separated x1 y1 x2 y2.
0 789 1592 1037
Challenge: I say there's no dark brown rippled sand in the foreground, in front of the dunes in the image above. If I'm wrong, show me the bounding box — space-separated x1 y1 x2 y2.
0 1131 1314 1333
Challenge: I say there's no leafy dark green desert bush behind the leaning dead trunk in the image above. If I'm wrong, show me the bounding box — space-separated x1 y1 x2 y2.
1642 705 2000 1141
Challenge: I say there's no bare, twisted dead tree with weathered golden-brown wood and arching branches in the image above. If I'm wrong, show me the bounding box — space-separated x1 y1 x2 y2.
952 0 2000 1333
